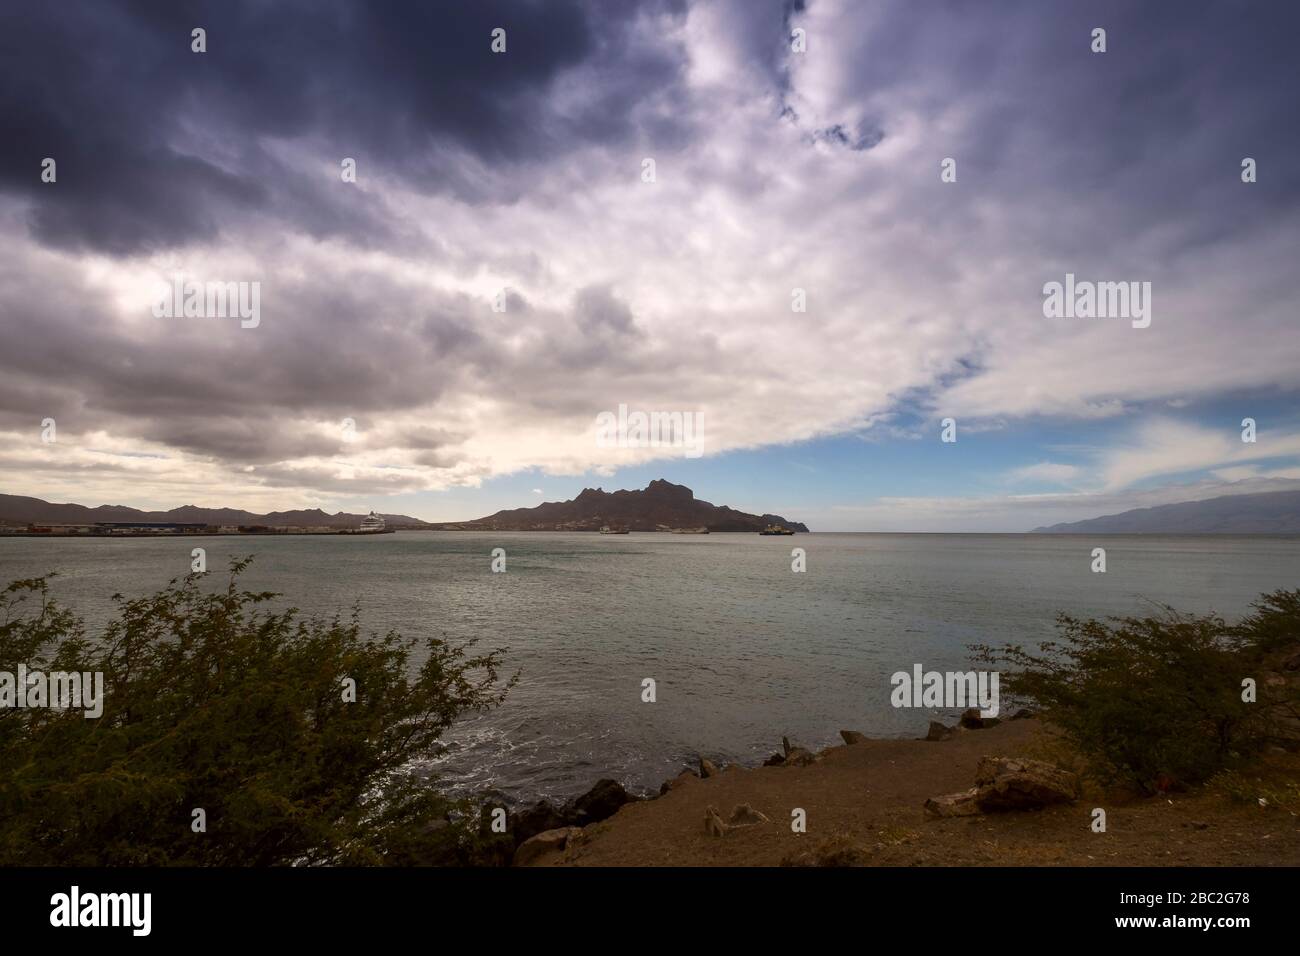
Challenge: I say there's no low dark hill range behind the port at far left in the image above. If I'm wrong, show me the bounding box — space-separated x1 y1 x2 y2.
0 494 428 528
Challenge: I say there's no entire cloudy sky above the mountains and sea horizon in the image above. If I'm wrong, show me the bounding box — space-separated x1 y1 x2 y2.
0 0 1300 531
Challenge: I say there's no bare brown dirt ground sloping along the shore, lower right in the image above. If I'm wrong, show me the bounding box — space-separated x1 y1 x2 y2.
536 719 1300 866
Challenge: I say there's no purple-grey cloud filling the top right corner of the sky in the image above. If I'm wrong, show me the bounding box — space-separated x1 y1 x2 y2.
813 0 1300 254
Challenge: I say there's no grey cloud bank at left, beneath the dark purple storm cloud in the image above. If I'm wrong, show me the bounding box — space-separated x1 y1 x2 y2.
0 254 491 463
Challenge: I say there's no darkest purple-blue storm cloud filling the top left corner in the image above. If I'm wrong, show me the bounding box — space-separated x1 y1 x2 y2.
0 0 680 254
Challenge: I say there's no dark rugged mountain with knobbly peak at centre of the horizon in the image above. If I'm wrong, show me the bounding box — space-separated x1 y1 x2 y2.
433 479 807 532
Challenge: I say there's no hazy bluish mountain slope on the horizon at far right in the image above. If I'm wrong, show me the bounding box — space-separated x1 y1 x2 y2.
1034 492 1300 535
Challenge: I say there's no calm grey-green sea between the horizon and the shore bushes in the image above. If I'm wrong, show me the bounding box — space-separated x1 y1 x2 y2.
0 532 1300 799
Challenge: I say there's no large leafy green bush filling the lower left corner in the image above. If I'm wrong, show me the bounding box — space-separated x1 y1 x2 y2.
0 561 515 866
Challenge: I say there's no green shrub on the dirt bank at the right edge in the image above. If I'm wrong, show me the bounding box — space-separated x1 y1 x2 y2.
975 591 1300 792
